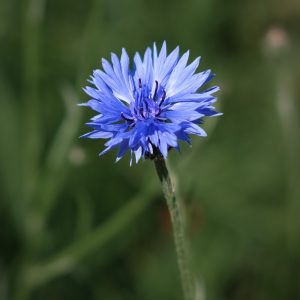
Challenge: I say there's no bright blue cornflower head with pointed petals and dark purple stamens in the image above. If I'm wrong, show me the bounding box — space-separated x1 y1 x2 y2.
81 42 220 162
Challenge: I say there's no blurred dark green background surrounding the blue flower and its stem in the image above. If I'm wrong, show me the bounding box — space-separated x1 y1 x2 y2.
0 0 300 300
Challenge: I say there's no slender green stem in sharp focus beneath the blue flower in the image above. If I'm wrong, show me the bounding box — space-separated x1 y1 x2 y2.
154 157 195 300
